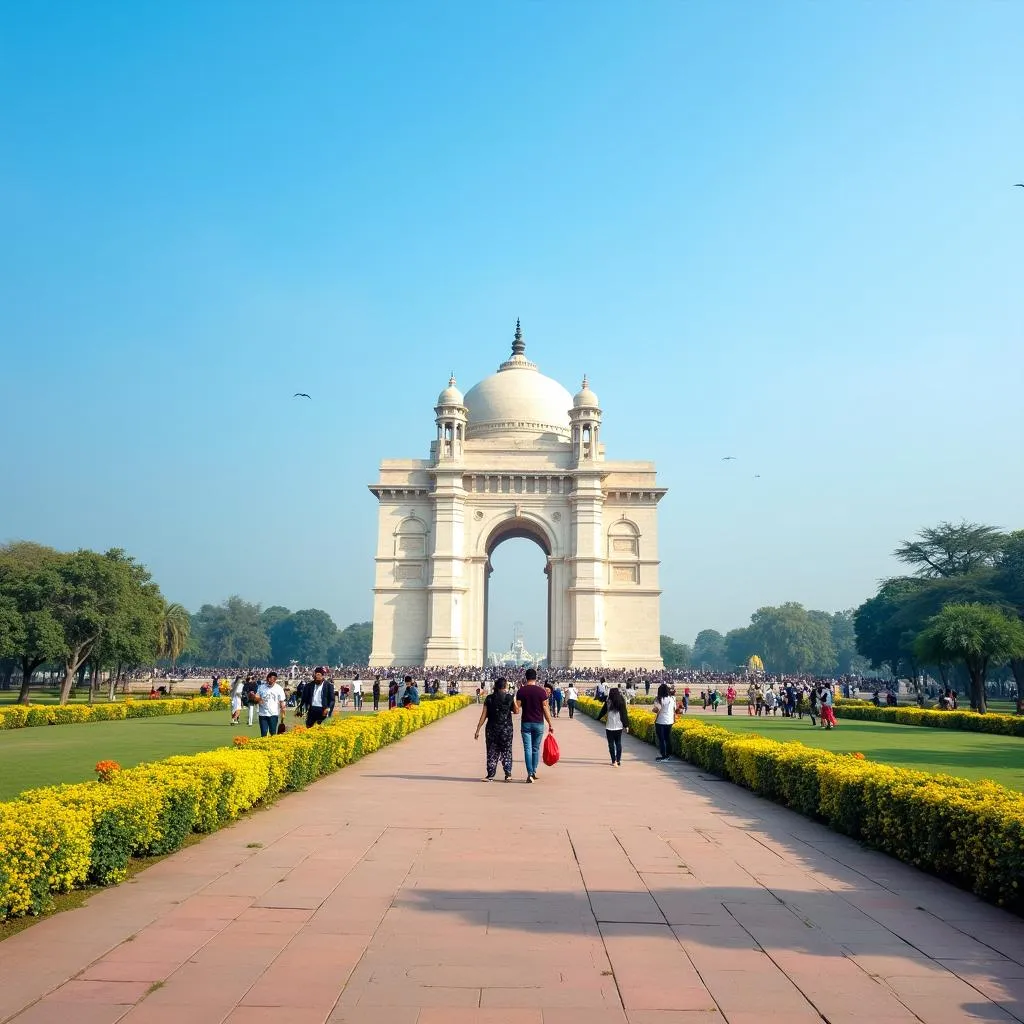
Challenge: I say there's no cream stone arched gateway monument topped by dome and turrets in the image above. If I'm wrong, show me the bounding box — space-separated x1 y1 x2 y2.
370 323 665 668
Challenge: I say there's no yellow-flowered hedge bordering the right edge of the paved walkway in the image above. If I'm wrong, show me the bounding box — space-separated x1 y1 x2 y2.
579 697 1024 913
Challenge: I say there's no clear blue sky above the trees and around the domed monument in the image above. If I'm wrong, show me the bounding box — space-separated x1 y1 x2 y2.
0 0 1024 647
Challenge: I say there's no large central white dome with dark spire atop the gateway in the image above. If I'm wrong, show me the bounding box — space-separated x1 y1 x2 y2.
465 321 572 439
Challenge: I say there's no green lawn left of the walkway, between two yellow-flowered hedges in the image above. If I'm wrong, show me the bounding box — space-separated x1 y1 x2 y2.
0 711 376 800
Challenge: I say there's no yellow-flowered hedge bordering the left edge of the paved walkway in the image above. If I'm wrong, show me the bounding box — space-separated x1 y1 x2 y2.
0 696 470 921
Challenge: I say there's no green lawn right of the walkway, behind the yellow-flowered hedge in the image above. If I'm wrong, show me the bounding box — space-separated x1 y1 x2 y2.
690 709 1024 792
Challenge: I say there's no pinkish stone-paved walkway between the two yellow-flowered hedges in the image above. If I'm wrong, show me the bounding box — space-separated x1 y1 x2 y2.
0 709 1024 1024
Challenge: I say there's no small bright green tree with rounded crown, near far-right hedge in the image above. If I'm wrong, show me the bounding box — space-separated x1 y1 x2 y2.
915 604 1024 715
